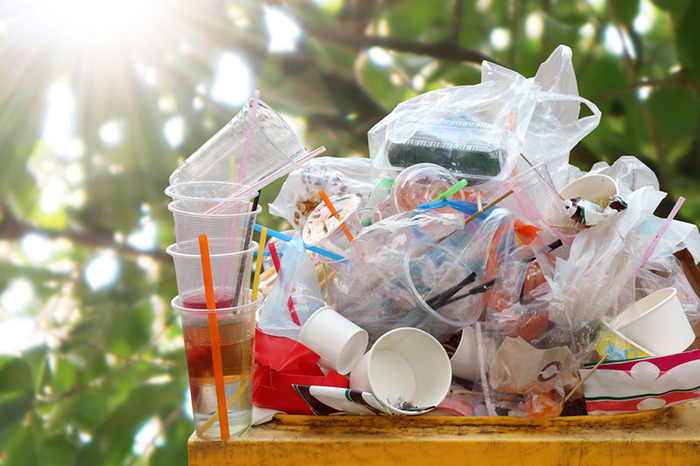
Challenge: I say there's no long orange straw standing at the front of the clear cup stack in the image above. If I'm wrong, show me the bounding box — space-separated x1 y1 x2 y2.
199 235 230 440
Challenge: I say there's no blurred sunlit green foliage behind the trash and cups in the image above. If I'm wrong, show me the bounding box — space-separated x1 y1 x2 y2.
0 0 700 466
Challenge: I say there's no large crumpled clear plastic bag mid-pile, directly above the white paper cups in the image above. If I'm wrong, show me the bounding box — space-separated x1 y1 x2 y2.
332 210 508 341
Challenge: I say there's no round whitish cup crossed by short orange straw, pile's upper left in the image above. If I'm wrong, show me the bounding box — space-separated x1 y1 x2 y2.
301 194 382 263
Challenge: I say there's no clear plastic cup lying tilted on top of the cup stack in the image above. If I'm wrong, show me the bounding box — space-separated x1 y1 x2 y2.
170 98 306 198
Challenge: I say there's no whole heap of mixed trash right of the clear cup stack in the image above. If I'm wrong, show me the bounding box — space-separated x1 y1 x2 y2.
170 46 700 422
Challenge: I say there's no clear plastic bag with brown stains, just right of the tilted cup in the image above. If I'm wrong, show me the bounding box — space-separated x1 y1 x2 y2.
269 157 379 231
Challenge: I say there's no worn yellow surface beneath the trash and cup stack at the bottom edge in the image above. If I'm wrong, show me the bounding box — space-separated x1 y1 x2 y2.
188 402 700 466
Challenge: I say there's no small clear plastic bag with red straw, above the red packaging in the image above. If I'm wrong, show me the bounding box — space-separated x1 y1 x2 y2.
257 233 325 340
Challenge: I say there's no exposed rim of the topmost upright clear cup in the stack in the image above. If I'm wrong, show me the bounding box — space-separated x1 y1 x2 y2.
165 181 258 214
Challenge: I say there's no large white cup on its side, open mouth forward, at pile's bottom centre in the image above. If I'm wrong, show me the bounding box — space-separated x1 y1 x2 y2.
350 328 452 415
